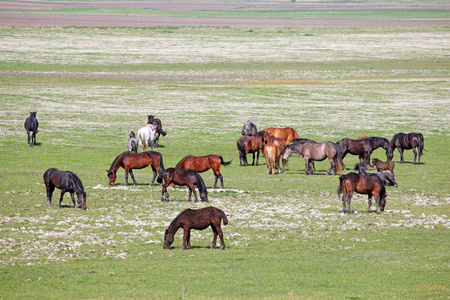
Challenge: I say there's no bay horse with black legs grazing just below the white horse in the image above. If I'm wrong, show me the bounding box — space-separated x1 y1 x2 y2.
106 151 164 185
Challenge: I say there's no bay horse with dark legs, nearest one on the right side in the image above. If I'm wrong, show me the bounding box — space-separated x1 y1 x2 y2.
338 165 386 214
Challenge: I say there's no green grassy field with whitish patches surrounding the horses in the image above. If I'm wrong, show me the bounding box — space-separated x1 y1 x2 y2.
0 27 450 299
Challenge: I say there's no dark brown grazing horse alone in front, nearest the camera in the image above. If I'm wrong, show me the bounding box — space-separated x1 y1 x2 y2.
163 206 228 250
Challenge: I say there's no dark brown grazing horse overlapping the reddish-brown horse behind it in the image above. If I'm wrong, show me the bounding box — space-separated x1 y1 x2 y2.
156 168 208 202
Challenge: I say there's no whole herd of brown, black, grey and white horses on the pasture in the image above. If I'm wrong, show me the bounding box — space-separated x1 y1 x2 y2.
24 112 424 249
